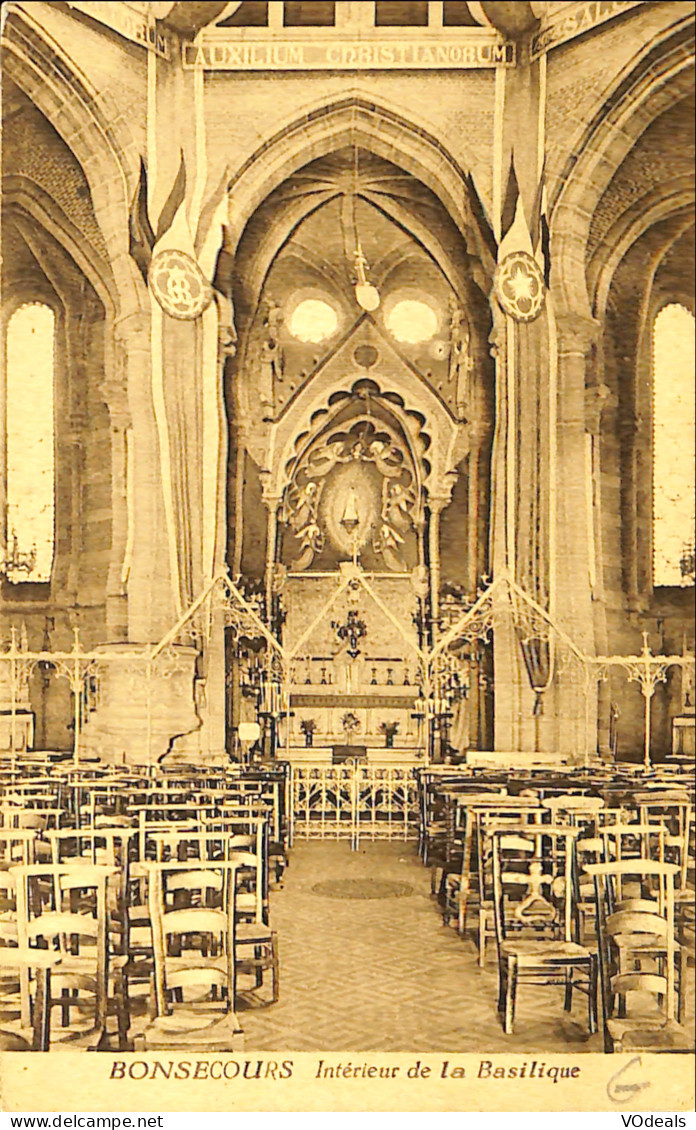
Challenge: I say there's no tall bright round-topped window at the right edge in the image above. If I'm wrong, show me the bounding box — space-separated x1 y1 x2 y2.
653 303 696 585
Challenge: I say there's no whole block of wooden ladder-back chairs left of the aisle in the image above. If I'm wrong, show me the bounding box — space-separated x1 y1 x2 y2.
0 767 286 1050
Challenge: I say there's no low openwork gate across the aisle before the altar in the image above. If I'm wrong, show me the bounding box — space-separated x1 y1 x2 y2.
288 762 418 850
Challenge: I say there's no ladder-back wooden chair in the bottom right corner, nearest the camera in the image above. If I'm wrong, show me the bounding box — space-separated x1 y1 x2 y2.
586 859 693 1052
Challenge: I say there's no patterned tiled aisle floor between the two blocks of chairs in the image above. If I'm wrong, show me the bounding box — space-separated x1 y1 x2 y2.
240 841 632 1053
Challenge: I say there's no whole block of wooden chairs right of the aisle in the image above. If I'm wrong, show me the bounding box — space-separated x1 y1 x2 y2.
420 789 694 1050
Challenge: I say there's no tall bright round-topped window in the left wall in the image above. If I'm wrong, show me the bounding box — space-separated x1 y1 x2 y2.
5 303 55 583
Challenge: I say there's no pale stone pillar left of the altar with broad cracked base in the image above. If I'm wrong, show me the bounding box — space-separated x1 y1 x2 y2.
81 311 201 763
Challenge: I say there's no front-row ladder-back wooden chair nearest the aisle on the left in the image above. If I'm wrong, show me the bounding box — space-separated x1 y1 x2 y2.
136 861 243 1052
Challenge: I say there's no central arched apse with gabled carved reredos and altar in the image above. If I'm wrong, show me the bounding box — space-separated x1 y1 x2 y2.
228 141 493 757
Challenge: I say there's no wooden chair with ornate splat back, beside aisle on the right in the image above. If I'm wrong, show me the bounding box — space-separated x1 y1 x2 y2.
490 824 597 1034
